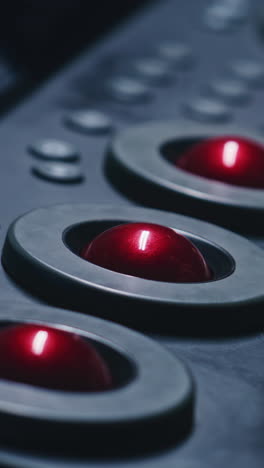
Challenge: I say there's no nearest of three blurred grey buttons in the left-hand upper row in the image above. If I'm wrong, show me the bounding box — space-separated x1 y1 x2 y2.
108 77 151 102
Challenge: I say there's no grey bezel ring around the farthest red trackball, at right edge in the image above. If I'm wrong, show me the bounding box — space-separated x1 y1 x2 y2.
106 120 264 231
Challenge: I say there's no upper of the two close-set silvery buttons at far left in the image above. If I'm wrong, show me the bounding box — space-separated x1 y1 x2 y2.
29 139 78 161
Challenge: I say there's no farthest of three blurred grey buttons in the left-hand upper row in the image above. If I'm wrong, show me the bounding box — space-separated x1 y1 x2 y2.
158 42 194 69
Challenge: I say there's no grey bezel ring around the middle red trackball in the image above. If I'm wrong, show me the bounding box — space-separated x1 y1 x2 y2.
2 204 264 332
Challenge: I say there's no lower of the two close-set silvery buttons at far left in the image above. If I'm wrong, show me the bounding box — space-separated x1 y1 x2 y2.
32 162 83 183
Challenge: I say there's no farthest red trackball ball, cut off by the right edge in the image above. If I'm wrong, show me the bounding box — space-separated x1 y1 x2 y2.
175 136 264 189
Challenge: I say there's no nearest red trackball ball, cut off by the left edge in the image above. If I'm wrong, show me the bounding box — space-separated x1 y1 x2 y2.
0 324 112 392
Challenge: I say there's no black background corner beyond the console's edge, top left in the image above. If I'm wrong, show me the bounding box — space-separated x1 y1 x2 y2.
0 0 151 115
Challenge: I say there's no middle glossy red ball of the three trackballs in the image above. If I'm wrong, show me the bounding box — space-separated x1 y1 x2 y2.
81 223 212 283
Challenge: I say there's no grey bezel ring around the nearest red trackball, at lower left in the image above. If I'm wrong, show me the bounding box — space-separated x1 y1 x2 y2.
0 301 194 453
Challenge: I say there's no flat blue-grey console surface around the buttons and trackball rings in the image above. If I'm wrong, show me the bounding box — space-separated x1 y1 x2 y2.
0 0 264 468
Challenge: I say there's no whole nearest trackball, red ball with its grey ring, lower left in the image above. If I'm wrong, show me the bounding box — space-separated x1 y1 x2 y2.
0 302 195 456
